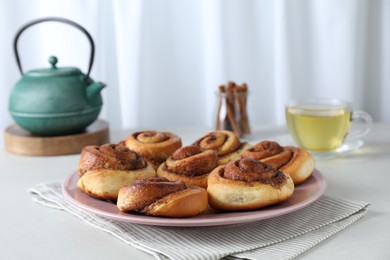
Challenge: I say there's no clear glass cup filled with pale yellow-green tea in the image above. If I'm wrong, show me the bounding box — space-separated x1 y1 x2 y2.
286 99 372 155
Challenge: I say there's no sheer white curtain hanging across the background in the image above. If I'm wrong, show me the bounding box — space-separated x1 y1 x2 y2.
0 0 390 146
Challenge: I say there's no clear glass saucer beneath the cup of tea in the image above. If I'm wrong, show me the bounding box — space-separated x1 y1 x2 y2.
274 135 364 159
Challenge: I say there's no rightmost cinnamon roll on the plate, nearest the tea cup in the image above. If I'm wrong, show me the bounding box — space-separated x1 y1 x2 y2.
241 141 315 185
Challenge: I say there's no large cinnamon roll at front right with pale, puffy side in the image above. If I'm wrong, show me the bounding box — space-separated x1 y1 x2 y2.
207 158 294 211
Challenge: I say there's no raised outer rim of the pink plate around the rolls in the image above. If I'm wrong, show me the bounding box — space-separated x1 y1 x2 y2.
62 169 327 227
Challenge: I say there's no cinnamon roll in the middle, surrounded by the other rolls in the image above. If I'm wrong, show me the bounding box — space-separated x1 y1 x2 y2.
157 145 218 188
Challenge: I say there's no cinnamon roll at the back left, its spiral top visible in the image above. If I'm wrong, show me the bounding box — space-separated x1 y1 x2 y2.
124 131 182 169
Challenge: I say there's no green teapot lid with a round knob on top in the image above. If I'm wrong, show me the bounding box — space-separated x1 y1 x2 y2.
25 56 82 77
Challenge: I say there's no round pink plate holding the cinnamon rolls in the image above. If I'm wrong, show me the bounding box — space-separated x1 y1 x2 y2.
63 170 326 227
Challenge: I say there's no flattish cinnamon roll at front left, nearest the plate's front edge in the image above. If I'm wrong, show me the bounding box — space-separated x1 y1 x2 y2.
117 177 208 217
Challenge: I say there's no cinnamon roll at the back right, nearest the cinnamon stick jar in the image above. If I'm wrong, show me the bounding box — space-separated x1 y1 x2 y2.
193 130 250 165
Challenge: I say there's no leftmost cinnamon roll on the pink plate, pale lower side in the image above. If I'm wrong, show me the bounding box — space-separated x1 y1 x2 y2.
77 144 156 200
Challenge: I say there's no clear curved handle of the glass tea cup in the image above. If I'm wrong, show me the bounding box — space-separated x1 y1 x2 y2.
346 110 373 141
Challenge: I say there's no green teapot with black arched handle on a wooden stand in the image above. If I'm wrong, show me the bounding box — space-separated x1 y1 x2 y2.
9 17 106 136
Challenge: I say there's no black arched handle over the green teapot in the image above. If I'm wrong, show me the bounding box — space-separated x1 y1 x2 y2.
14 17 95 78
